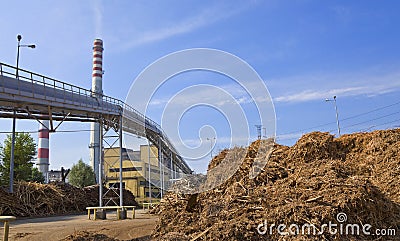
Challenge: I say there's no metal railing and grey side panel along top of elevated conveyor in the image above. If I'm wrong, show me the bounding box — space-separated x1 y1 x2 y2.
0 62 191 172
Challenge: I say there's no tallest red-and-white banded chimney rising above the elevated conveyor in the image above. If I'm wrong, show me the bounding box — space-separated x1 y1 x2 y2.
89 39 103 183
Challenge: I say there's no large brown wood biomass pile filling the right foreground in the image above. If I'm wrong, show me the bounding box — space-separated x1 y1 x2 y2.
153 129 400 240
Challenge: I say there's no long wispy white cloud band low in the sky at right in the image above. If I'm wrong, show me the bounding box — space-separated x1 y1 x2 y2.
150 67 400 107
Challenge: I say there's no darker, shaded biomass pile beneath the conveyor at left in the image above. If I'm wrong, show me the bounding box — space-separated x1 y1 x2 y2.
0 182 137 217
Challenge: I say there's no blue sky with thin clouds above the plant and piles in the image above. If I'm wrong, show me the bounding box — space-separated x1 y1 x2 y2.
0 0 400 173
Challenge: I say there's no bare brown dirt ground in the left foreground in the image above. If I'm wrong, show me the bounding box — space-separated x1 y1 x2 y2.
4 210 158 241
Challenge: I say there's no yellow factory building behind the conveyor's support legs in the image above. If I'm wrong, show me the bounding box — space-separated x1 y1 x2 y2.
104 145 172 203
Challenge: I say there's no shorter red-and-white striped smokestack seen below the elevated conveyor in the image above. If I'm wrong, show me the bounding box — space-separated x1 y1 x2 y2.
37 120 50 177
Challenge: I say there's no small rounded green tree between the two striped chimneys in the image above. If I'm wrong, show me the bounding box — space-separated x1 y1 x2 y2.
68 159 96 187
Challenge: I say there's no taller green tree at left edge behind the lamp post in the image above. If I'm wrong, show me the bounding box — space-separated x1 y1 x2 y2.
0 133 36 185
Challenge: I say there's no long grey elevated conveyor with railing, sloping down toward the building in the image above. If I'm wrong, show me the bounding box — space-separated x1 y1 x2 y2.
0 63 192 174
